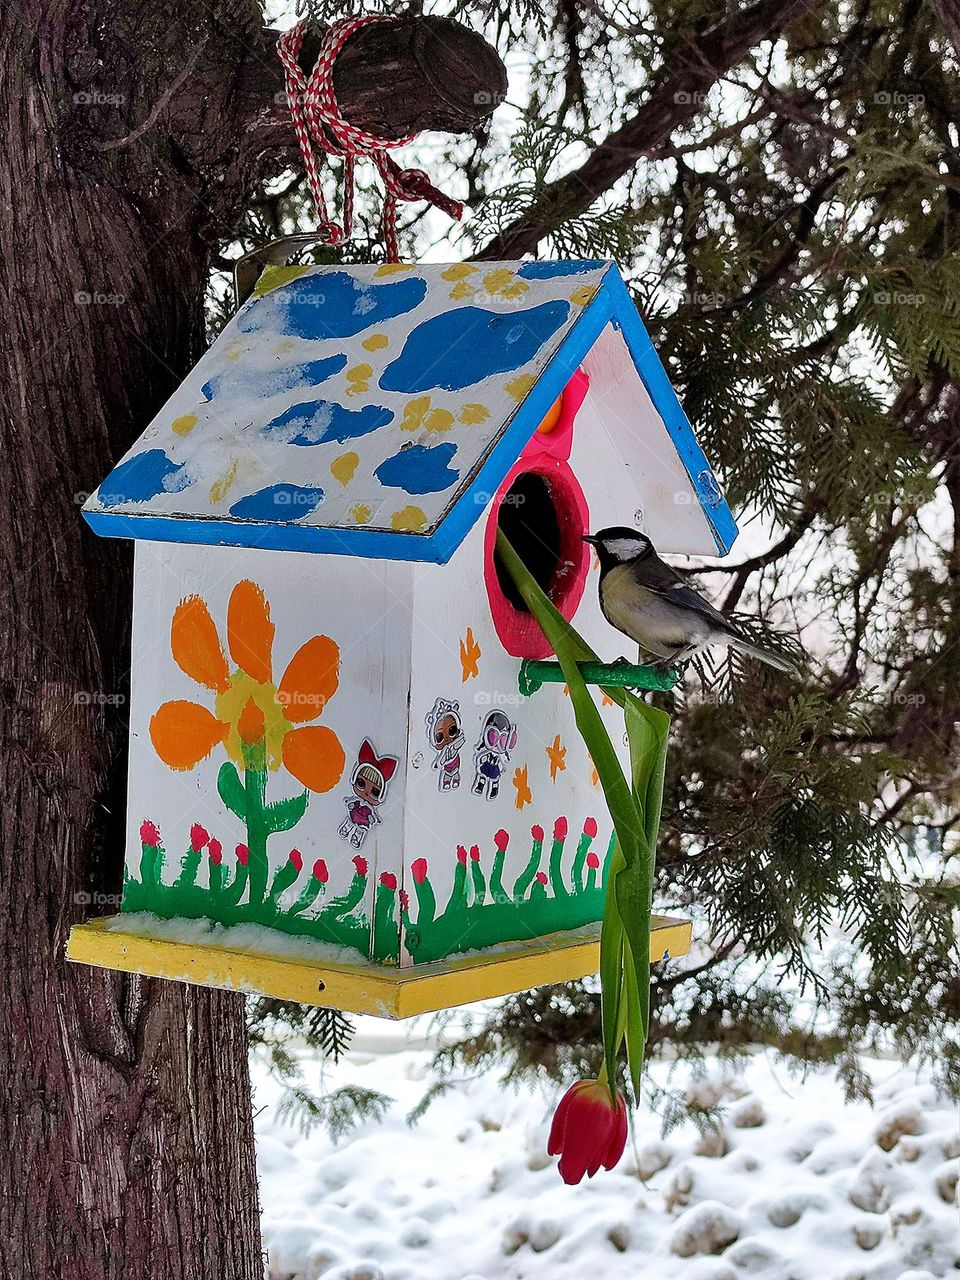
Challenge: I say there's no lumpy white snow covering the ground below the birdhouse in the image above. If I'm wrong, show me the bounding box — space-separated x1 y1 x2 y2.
253 1020 960 1280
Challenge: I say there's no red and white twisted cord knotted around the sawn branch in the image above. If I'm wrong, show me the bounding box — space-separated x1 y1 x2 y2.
276 14 463 262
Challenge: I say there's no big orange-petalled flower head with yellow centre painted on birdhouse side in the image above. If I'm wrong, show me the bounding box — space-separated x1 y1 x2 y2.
150 580 346 792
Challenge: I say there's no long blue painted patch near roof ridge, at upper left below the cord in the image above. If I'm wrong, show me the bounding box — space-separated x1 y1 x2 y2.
237 271 426 338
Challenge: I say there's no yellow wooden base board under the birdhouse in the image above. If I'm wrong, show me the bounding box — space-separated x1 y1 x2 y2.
67 915 690 1018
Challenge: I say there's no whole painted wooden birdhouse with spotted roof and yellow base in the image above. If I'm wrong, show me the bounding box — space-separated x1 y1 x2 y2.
69 261 736 1016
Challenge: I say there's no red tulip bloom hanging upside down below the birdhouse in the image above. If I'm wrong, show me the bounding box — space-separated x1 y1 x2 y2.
547 1080 627 1187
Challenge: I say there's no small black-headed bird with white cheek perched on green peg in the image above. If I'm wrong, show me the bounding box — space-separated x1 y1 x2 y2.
584 527 796 672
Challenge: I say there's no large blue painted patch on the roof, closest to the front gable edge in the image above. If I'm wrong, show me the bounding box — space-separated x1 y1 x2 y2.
380 298 570 393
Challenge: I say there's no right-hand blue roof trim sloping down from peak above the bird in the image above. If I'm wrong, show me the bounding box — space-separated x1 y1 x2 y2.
604 269 740 556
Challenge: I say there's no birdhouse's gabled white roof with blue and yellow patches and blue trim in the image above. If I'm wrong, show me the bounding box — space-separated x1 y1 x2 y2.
83 261 736 563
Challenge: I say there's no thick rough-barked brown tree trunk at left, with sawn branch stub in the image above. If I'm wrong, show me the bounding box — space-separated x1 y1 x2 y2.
0 0 512 1280
